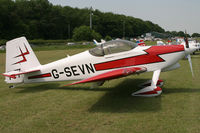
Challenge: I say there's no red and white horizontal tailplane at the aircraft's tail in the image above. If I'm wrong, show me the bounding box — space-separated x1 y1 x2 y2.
2 69 40 79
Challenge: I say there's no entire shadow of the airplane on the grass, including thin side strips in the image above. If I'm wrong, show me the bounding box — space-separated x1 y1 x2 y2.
18 79 200 113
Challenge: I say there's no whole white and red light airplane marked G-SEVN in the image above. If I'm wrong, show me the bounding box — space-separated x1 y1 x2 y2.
3 37 195 97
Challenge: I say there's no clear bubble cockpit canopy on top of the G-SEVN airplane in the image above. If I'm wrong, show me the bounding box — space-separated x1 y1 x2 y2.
89 40 137 56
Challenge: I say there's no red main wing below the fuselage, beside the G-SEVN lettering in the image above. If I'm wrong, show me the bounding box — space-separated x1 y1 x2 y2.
65 67 147 86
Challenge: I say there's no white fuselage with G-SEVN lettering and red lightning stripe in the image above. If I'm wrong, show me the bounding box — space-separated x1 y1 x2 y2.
23 45 185 83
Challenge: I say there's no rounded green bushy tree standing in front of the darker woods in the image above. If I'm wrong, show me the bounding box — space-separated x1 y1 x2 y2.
72 26 101 41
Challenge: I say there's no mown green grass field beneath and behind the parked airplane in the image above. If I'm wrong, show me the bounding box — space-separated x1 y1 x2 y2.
0 48 200 133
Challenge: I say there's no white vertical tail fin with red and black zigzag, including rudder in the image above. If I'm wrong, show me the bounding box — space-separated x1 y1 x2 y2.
6 37 40 83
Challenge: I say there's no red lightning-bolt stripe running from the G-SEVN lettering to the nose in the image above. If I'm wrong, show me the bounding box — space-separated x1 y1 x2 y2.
94 45 184 71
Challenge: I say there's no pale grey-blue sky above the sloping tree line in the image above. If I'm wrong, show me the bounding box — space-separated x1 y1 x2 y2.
49 0 200 34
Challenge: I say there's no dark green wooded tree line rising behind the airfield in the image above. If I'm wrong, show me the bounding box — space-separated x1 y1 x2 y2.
0 0 198 39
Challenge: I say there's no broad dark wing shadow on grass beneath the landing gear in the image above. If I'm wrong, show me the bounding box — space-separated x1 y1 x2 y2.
89 79 161 113
